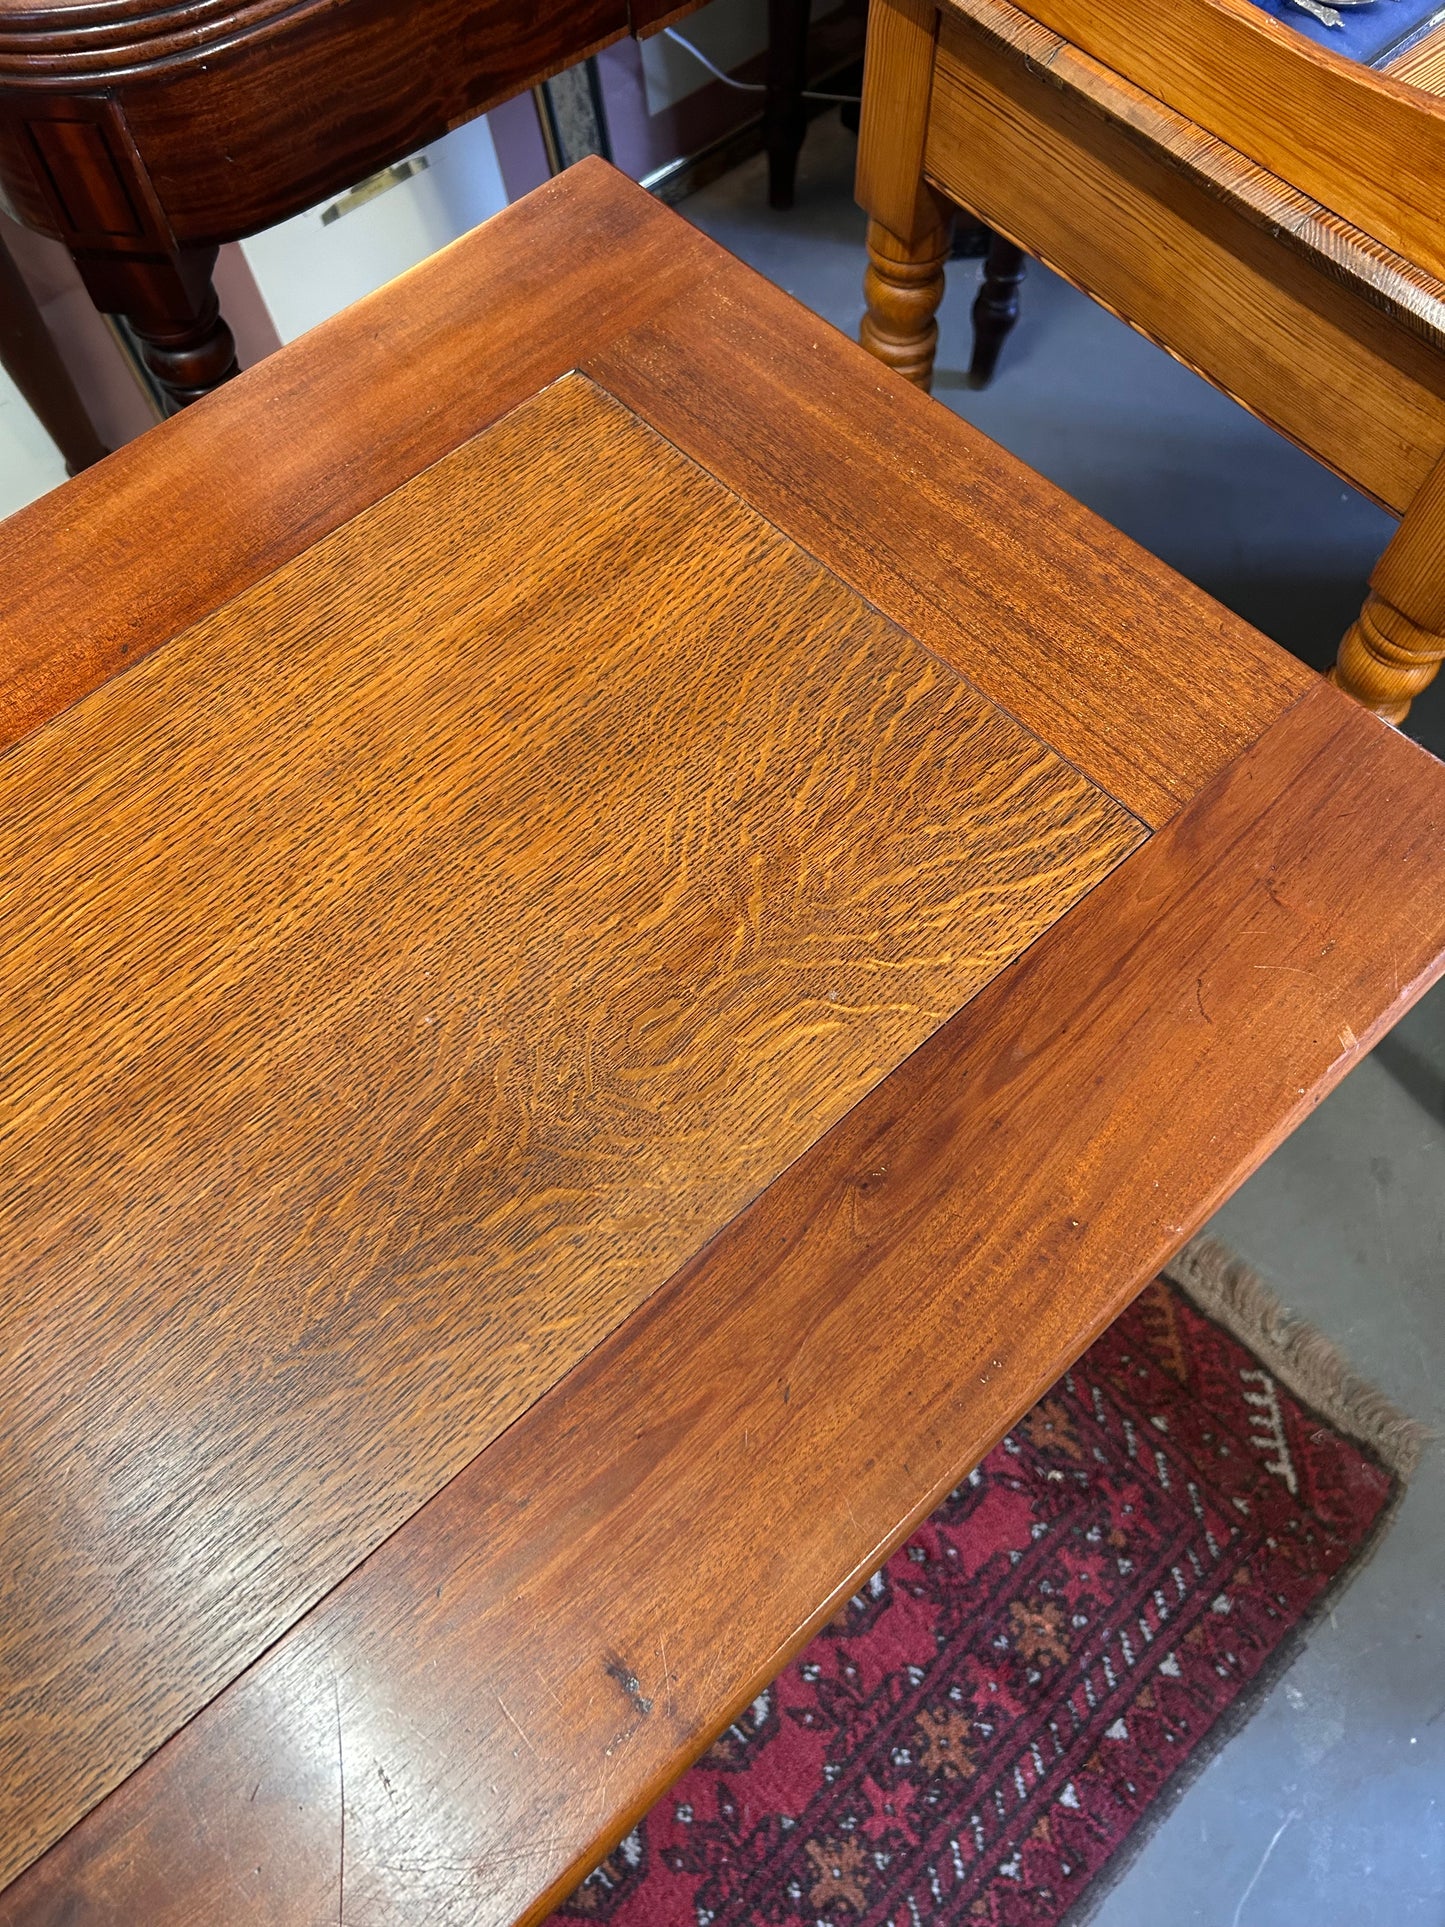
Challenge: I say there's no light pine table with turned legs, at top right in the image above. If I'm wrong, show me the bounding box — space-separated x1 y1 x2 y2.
857 0 1445 721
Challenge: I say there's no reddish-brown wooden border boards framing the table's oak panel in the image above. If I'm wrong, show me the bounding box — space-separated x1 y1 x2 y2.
0 164 1445 1927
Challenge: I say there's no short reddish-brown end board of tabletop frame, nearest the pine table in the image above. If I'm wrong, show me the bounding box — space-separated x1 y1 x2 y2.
584 262 1314 827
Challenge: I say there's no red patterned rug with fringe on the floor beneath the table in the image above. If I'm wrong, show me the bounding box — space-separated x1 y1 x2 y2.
561 1241 1420 1927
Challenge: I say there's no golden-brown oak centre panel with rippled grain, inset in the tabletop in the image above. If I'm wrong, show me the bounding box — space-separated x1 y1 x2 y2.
0 376 1143 1877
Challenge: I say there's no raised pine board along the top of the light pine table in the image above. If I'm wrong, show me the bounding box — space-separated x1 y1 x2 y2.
1009 0 1445 276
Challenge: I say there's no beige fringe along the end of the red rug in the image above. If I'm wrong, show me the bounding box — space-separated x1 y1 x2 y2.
1164 1237 1435 1484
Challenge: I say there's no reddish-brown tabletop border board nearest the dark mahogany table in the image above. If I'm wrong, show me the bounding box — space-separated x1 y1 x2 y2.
0 162 712 744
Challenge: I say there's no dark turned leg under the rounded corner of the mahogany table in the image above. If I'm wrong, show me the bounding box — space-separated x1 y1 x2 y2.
75 247 237 414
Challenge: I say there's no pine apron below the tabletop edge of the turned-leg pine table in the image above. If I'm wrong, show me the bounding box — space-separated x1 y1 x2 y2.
927 0 1445 515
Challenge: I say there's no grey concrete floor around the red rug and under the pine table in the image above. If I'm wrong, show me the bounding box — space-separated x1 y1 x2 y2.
682 118 1445 1927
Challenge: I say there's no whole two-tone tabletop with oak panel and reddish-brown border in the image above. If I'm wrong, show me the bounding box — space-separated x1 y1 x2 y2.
0 164 1445 1927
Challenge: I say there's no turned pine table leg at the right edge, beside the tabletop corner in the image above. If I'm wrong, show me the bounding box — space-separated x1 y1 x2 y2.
1329 443 1445 723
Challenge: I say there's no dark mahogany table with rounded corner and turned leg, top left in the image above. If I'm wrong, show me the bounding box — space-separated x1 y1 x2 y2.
0 0 824 418
